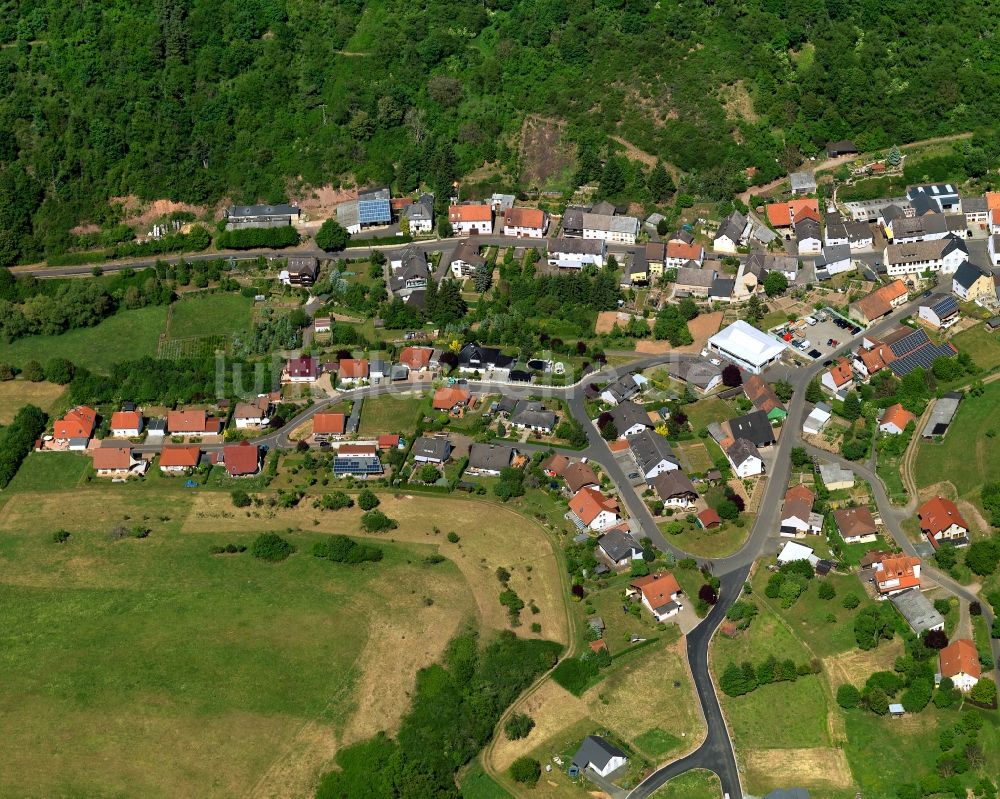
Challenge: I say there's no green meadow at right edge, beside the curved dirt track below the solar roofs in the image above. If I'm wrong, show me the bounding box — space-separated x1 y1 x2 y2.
914 381 1000 510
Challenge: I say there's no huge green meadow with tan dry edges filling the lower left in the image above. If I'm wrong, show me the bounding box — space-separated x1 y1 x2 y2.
0 482 475 797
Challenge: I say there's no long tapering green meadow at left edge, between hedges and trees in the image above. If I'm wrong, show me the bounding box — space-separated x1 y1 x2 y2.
0 305 167 371
